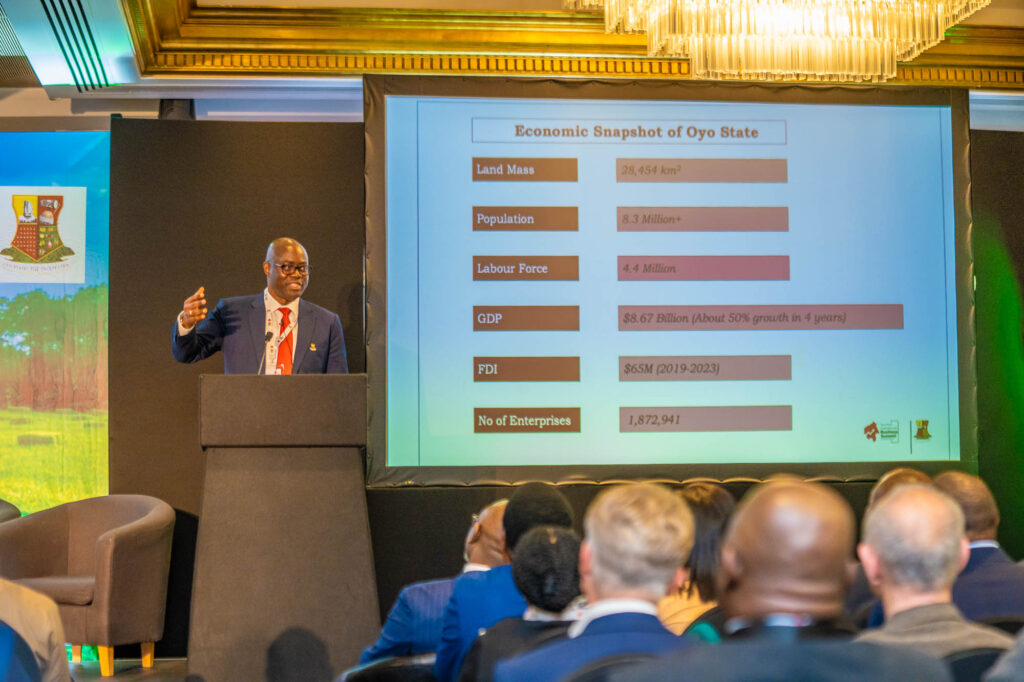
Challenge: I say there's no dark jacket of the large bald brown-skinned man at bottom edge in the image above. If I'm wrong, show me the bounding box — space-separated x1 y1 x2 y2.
612 628 950 682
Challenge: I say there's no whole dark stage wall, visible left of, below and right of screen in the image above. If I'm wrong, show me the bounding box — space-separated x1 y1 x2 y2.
110 121 1024 655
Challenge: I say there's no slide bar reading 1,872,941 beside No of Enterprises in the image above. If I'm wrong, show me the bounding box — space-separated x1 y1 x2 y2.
618 404 793 433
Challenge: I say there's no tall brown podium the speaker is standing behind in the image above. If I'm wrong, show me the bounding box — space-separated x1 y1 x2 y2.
188 375 380 682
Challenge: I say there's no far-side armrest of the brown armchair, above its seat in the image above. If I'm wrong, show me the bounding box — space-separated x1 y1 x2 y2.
0 507 68 580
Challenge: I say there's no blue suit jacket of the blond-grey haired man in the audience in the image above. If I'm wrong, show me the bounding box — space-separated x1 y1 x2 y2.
495 613 692 682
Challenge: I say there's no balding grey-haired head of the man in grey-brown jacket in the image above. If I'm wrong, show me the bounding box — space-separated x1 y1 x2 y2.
859 483 967 589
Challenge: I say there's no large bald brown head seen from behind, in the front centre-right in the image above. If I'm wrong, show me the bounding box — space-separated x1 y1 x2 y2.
718 479 855 619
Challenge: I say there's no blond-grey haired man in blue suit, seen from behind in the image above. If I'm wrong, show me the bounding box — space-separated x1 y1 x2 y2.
495 483 697 682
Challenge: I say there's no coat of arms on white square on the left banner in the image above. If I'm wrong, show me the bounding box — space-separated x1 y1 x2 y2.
0 187 85 283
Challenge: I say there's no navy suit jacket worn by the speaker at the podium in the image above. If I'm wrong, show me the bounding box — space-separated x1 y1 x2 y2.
171 294 348 374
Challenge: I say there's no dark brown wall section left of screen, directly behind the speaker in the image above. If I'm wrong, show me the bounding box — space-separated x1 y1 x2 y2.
110 120 366 654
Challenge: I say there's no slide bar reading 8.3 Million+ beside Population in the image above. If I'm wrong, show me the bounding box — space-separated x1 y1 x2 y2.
615 206 790 232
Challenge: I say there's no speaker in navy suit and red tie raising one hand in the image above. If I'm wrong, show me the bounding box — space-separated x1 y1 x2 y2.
171 238 348 374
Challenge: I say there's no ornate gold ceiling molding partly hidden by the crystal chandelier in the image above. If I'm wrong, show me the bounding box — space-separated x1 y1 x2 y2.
121 0 1024 89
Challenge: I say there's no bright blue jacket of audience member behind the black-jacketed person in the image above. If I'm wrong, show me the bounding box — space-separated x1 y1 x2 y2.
434 564 526 682
